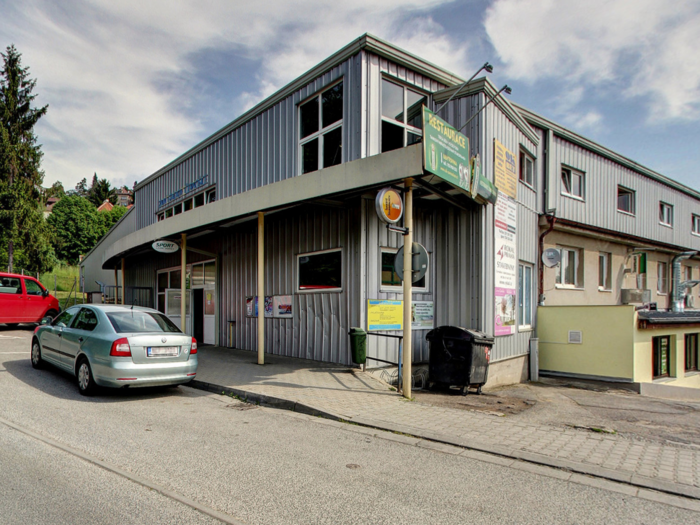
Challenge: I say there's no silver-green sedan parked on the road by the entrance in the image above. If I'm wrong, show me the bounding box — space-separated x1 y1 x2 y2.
32 305 197 395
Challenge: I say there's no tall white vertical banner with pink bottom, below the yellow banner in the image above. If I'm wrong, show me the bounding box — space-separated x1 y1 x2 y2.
494 192 518 335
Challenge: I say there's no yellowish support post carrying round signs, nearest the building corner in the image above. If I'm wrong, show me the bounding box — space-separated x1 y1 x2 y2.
402 179 413 399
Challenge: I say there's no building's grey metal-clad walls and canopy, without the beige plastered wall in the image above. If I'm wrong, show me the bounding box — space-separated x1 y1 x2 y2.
83 35 700 382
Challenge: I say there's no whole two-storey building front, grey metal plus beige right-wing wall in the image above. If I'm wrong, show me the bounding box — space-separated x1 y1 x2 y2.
82 35 700 384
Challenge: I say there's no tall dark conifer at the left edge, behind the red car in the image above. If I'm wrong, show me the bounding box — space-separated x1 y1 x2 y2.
0 45 53 272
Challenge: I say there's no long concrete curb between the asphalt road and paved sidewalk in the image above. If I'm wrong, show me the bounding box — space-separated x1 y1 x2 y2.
188 380 700 500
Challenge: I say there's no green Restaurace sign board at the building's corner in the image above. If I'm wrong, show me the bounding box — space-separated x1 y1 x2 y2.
423 106 471 193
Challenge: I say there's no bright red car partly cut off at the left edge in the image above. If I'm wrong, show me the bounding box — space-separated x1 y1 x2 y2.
0 272 59 325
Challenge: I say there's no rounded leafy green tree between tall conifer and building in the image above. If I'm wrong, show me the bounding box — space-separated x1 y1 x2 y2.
47 195 104 264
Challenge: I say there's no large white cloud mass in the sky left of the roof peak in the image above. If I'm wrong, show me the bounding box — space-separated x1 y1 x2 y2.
0 0 468 188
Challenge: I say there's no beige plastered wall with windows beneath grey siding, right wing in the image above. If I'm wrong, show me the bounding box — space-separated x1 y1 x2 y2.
544 231 700 309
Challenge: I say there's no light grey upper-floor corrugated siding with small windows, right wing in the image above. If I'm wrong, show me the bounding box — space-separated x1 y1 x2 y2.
552 136 700 250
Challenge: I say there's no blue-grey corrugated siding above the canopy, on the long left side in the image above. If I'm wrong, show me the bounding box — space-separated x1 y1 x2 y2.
136 54 362 229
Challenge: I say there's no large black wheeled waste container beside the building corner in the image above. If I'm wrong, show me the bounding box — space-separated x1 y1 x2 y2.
426 326 493 395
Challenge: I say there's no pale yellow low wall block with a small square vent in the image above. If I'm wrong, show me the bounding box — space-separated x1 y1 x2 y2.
537 306 635 381
